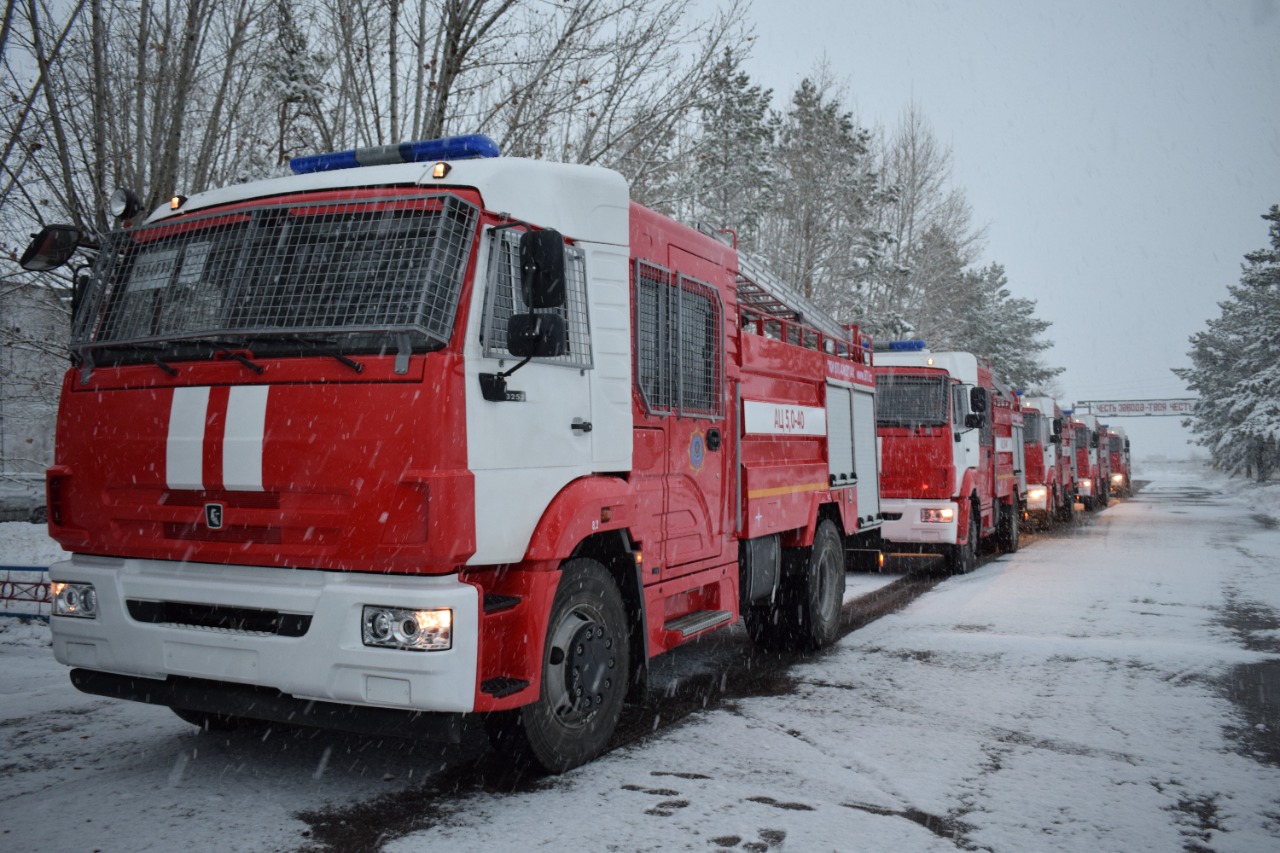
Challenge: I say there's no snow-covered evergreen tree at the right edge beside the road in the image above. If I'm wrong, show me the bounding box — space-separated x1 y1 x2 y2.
1174 205 1280 480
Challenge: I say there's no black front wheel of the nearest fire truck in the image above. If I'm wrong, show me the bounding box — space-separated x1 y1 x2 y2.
485 560 630 774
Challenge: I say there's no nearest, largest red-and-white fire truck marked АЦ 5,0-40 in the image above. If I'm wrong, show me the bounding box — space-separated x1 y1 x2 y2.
24 136 881 771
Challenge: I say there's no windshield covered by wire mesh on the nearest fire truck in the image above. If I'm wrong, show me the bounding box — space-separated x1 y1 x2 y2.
72 195 479 362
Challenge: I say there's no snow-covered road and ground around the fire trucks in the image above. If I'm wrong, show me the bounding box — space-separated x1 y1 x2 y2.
0 466 1280 853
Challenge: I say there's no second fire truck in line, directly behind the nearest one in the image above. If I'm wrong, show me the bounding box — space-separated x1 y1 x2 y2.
876 341 1025 573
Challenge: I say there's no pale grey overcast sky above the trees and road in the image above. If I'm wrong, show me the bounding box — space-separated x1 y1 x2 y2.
721 0 1280 456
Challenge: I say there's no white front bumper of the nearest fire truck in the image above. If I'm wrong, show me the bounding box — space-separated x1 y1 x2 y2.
49 555 479 712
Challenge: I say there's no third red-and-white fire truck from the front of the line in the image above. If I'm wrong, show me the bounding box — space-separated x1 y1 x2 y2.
1021 397 1075 523
